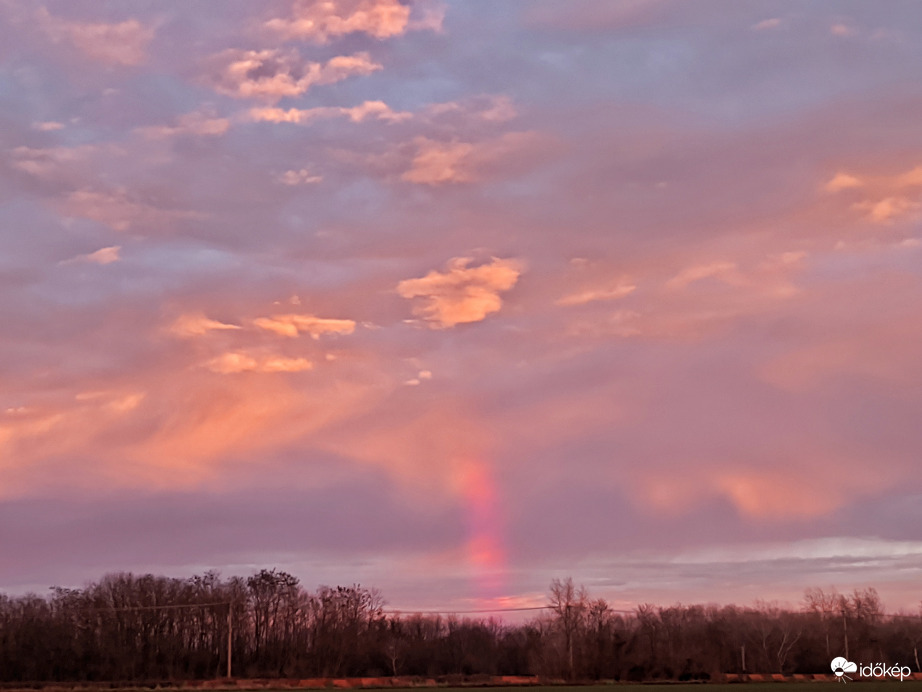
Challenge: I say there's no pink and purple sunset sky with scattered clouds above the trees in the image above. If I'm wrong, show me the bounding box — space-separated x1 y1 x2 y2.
0 0 922 611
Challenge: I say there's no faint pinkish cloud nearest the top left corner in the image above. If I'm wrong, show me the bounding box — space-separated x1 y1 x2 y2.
37 8 154 65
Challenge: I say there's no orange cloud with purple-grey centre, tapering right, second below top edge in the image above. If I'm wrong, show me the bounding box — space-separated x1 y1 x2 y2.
209 49 381 103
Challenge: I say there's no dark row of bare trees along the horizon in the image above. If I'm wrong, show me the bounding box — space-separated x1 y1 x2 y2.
0 570 922 683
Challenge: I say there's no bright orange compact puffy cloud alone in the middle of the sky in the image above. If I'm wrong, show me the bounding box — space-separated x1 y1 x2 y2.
397 257 522 329
